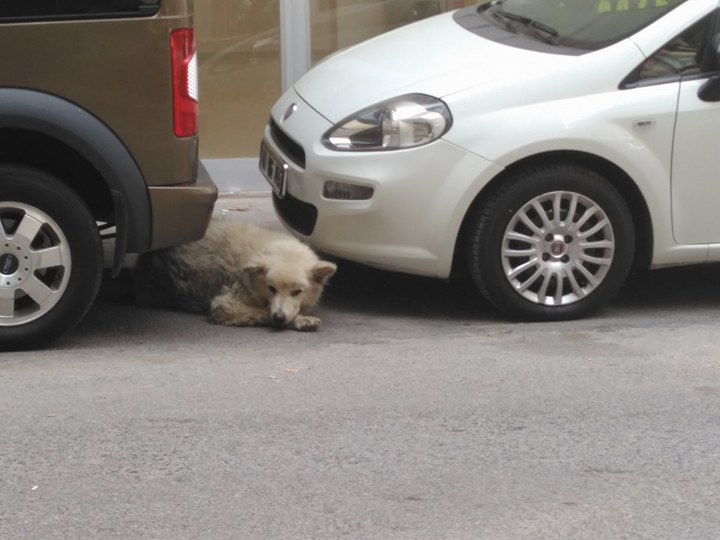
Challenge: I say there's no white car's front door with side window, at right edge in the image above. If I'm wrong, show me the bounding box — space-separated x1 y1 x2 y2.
658 10 720 245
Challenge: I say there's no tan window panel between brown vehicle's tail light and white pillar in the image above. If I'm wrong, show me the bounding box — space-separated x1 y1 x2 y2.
195 0 280 159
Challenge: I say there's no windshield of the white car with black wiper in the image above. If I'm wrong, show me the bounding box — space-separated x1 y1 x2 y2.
478 0 685 50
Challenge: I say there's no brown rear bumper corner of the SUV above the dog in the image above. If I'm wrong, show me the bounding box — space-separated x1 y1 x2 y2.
148 163 218 249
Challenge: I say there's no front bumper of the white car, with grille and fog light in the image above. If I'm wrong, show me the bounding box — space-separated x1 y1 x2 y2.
263 91 500 278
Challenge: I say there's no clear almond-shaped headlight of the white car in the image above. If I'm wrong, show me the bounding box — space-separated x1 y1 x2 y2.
323 94 452 151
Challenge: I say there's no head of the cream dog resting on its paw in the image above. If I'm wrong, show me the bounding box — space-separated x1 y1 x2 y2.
244 254 337 328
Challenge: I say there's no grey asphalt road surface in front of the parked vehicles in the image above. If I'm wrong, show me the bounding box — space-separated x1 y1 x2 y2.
0 199 720 540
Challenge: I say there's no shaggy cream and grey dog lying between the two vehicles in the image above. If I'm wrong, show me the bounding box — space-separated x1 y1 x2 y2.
133 220 336 331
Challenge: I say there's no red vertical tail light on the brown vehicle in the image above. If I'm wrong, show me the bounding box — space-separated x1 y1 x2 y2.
170 28 198 137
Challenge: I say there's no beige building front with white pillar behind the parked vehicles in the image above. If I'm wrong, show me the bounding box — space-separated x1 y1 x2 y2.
195 0 482 191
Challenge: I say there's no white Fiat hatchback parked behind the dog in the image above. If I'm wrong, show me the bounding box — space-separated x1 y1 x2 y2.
260 0 720 320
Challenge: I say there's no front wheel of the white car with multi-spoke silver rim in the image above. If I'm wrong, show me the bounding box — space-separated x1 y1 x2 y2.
465 164 635 321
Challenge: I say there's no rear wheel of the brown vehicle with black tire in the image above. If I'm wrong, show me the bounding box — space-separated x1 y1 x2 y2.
0 164 103 350
